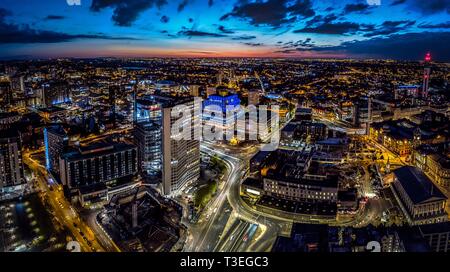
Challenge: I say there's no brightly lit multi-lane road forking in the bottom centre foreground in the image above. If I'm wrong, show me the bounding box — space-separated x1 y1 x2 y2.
185 143 292 251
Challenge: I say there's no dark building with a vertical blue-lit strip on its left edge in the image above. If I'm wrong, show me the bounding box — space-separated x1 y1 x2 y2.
44 125 69 175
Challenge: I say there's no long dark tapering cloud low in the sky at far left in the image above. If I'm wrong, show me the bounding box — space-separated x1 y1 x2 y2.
0 8 137 44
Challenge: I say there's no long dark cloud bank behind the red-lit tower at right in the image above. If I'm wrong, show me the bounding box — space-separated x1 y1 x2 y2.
311 32 450 62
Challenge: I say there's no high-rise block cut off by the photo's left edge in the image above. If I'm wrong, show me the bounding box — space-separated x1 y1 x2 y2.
0 130 26 193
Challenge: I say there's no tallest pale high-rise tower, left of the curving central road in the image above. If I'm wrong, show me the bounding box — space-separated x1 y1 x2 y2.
162 98 201 195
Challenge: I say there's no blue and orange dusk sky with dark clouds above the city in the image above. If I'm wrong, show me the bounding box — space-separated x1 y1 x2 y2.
0 0 450 61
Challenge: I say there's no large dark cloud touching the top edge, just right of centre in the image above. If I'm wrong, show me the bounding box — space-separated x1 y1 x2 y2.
220 0 315 28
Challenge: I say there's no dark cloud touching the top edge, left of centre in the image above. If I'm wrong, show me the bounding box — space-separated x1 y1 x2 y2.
90 0 167 26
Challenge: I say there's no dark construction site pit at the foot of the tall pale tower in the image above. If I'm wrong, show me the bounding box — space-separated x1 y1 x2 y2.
97 187 185 252
